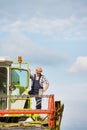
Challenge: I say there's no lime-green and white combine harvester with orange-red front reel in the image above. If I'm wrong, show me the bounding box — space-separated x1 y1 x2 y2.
0 56 64 130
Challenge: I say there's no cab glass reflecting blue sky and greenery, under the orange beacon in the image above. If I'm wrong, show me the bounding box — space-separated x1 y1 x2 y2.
11 69 28 95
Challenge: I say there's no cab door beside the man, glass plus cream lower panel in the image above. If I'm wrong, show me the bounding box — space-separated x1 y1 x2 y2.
10 68 29 109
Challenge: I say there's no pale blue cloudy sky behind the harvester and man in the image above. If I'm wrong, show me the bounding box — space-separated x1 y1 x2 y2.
0 0 87 130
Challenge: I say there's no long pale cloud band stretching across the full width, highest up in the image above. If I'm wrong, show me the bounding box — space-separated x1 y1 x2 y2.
0 16 87 39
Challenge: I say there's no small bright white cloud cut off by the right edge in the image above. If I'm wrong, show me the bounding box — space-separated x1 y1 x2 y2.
68 56 87 73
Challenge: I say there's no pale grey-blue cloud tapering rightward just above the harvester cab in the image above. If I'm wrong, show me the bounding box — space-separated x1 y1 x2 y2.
0 32 66 65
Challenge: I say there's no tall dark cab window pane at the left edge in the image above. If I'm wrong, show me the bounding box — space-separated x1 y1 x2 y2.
0 67 7 109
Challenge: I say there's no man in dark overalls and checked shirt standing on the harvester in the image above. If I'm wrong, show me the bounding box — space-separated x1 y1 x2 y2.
25 67 49 109
